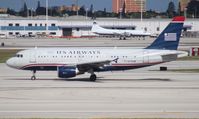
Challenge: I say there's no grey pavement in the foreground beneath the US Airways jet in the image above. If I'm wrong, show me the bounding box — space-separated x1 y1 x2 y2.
0 61 199 118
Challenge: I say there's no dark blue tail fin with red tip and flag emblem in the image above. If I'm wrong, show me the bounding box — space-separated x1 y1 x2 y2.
146 16 185 50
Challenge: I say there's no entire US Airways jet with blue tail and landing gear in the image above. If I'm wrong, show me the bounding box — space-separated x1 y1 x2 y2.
6 16 187 81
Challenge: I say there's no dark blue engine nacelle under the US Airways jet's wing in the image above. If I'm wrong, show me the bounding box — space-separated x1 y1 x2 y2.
58 66 79 78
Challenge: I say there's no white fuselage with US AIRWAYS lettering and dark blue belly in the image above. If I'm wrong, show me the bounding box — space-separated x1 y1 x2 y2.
7 48 187 71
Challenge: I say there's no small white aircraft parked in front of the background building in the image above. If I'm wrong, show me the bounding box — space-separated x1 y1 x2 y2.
91 22 151 40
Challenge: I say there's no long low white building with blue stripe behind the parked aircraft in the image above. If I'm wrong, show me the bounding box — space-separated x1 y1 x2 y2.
0 16 199 37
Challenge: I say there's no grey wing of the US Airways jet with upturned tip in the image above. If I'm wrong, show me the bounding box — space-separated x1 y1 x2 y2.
77 58 118 72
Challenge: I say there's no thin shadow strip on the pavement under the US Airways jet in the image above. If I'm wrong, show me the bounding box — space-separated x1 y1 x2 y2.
6 77 172 83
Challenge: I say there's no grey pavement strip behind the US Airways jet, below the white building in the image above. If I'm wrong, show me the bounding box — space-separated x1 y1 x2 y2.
0 37 199 50
